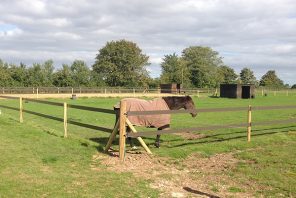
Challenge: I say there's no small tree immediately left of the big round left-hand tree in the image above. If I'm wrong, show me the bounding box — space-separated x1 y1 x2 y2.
70 60 90 87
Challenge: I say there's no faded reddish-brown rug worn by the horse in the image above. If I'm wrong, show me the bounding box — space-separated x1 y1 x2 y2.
115 98 171 128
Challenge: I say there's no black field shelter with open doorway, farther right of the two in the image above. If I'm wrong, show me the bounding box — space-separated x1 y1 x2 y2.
220 84 255 98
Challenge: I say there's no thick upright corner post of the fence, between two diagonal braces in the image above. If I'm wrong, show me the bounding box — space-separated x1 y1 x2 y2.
119 100 126 161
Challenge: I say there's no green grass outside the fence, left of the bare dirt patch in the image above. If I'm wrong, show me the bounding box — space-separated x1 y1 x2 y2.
0 115 158 197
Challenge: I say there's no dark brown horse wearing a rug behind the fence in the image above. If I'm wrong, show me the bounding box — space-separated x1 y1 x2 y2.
114 96 197 148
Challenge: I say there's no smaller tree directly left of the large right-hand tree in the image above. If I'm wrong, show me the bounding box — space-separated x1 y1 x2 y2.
160 53 190 87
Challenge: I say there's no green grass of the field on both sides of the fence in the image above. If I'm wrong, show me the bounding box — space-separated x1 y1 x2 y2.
0 95 296 197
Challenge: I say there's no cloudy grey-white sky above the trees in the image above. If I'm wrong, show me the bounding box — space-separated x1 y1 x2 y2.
0 0 296 85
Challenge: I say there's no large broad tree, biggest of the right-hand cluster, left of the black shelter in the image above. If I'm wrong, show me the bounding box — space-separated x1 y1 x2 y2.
182 46 223 87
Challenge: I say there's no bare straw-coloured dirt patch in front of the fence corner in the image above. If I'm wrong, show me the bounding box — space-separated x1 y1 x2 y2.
91 152 253 197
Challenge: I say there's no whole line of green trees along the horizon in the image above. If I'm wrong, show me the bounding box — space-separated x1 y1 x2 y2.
0 40 296 88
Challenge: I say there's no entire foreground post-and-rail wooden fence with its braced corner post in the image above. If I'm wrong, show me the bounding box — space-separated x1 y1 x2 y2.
0 95 296 160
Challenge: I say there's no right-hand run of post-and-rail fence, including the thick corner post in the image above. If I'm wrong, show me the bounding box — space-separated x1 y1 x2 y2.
119 102 296 160
